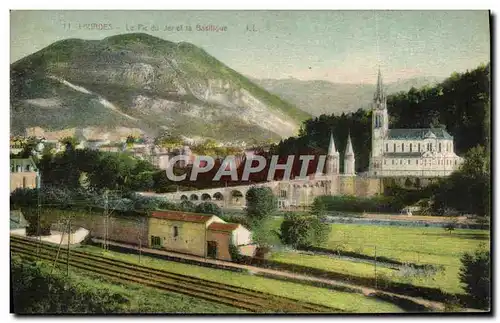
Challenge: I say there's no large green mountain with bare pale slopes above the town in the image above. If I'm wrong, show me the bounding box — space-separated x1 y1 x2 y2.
10 33 310 141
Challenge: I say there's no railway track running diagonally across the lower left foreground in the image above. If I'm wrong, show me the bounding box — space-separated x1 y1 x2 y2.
10 236 342 313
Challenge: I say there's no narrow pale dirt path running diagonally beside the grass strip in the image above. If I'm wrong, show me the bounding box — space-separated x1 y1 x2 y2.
92 239 445 311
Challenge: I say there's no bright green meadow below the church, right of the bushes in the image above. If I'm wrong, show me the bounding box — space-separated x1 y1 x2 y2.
271 220 489 293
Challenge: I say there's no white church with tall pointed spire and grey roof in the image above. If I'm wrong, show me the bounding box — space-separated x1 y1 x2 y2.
369 70 463 177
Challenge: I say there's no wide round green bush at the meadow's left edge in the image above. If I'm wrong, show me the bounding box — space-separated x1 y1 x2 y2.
280 213 329 248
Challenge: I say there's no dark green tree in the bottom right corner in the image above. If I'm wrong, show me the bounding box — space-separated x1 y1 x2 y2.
459 248 491 309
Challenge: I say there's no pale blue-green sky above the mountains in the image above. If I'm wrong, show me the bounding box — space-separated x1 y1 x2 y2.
10 11 490 83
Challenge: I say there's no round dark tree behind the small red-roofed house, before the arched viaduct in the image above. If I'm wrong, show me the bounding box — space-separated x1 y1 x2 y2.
246 187 278 224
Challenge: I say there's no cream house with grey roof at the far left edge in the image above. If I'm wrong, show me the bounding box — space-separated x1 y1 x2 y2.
10 157 40 192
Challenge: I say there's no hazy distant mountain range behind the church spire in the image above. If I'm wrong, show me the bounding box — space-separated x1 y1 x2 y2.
252 77 444 116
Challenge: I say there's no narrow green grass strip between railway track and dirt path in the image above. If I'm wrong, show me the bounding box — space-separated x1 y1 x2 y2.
78 246 402 313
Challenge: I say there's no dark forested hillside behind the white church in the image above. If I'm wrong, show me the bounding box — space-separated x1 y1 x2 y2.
273 64 491 172
